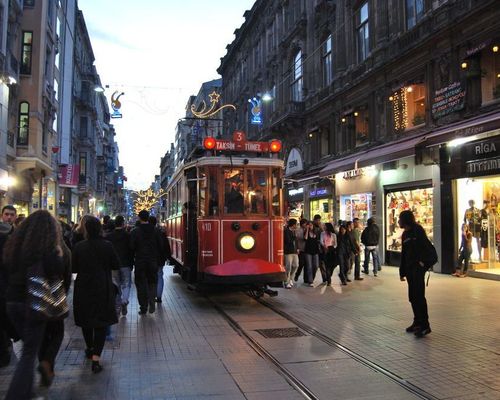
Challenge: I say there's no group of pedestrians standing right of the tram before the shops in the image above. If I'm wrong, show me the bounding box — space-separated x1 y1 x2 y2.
284 215 381 289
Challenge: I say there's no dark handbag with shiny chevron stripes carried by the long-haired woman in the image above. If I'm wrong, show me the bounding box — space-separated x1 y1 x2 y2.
26 261 69 321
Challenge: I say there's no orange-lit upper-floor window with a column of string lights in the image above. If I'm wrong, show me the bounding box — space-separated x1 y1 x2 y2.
389 83 426 132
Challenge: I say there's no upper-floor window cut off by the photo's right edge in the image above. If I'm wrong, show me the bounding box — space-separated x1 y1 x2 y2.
481 44 500 104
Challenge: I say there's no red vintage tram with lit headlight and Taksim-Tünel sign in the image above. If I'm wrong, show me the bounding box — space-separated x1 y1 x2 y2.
166 132 285 288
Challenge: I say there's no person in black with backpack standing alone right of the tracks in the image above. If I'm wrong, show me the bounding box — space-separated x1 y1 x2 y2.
399 210 437 338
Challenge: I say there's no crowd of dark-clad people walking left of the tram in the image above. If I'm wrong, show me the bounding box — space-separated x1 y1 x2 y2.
0 205 171 400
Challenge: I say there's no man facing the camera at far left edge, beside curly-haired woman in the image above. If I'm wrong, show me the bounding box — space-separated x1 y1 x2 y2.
0 206 17 367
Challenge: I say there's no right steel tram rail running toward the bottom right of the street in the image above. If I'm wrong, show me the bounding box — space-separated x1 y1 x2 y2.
256 293 439 400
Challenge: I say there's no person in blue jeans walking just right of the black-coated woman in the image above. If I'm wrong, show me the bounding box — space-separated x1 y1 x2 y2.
106 215 134 315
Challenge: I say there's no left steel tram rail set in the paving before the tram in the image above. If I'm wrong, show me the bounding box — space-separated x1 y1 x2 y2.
204 295 320 400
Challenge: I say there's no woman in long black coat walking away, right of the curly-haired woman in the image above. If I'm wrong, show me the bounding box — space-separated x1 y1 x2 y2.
72 217 120 373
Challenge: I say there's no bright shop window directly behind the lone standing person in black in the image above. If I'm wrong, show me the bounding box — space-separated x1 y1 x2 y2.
386 188 434 252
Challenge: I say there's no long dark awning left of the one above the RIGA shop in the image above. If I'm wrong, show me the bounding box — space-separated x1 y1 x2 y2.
320 136 424 176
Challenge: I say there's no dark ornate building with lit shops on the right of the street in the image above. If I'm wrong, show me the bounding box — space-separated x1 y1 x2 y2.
219 0 500 274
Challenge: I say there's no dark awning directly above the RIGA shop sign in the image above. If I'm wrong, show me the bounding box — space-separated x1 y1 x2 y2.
423 112 500 147
